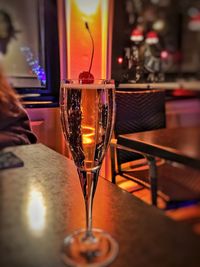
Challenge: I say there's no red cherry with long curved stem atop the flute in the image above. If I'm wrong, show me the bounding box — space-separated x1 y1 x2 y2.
78 22 94 84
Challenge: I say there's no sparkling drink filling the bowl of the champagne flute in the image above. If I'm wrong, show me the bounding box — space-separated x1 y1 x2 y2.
61 86 114 173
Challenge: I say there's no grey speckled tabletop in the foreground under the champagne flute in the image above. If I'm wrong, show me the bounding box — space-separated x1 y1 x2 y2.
0 144 200 267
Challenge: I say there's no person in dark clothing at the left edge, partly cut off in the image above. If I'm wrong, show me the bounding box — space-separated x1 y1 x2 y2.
0 69 37 149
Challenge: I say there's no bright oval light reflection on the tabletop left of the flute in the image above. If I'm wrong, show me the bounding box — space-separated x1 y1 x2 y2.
27 188 46 235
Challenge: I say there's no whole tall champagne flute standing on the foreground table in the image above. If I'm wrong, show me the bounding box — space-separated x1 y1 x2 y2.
60 79 118 267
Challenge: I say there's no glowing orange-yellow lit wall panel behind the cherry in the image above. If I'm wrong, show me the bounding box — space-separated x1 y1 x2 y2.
65 0 109 78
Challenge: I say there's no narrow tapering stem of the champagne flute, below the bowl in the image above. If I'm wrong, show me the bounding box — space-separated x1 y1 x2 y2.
79 168 100 239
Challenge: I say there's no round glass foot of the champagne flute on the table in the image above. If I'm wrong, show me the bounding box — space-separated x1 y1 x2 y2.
62 229 118 267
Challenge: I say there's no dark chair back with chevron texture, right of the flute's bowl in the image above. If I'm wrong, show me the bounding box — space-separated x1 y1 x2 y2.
114 90 166 168
